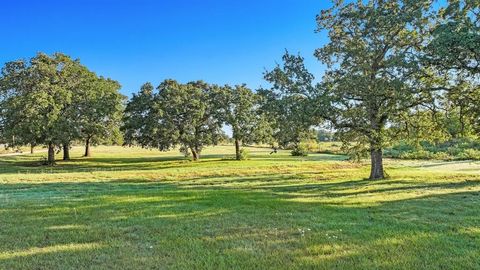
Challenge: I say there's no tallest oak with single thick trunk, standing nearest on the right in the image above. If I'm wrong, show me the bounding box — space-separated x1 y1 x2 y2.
315 1 432 179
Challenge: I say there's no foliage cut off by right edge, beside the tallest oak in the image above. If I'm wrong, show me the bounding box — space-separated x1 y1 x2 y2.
424 0 480 137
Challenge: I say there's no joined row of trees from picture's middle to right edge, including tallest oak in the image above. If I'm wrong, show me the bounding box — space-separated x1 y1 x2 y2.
125 0 480 179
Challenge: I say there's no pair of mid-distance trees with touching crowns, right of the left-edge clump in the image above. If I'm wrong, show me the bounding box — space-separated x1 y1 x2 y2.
122 80 270 160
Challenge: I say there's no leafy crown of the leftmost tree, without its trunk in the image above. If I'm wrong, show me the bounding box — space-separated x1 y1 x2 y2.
1 54 73 149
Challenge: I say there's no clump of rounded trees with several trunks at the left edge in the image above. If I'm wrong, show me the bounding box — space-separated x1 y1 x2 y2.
0 53 124 164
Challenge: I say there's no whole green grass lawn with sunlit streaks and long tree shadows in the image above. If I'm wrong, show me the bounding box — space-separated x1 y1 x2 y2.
0 146 480 269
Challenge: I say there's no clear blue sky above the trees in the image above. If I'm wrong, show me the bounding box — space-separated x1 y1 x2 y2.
0 0 329 95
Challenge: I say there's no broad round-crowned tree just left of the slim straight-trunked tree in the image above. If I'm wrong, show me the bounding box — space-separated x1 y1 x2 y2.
122 80 223 160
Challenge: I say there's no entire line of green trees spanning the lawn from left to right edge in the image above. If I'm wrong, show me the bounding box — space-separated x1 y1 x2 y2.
0 0 480 179
